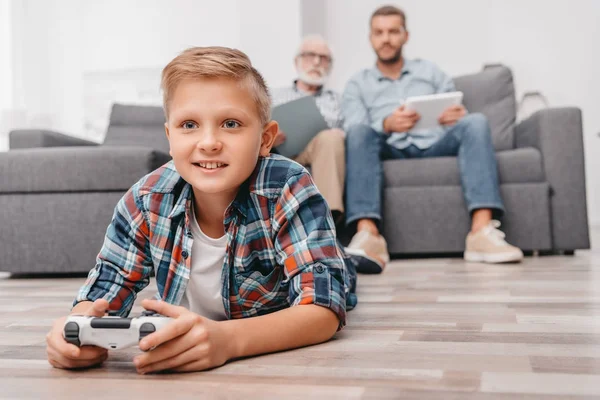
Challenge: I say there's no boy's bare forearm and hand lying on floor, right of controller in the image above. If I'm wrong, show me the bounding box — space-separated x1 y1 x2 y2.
133 300 339 373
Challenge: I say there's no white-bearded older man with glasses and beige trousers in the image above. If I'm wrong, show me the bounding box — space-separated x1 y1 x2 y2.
272 35 346 222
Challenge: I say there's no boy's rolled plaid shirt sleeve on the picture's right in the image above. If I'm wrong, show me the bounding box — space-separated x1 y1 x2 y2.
273 171 350 329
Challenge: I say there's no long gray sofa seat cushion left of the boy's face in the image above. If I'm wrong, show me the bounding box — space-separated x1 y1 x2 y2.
0 146 170 194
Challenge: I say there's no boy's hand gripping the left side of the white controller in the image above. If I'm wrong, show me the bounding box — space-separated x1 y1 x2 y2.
46 299 108 369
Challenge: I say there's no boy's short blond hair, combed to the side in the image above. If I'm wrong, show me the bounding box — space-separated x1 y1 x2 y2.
160 46 271 125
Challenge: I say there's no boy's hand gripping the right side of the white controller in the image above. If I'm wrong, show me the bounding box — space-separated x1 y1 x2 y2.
133 300 233 374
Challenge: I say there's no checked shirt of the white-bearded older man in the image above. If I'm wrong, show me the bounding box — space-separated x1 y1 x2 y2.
271 81 343 129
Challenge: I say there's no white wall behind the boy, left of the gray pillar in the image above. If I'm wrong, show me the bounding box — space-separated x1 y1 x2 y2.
9 0 301 141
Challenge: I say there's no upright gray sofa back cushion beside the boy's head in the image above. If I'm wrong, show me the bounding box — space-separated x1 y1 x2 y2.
103 104 169 154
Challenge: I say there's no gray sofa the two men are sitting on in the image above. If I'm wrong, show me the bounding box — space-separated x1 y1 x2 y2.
383 65 590 254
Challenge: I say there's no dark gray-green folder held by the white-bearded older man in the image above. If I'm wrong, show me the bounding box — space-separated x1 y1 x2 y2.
271 96 329 158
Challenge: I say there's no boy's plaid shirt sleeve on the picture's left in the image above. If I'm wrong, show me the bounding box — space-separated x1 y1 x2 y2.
74 186 153 316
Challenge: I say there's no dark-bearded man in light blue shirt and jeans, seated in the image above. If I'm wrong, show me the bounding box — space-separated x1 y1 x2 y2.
342 6 523 272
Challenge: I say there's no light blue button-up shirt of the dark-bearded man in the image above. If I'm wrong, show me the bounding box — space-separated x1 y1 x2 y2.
342 59 456 149
